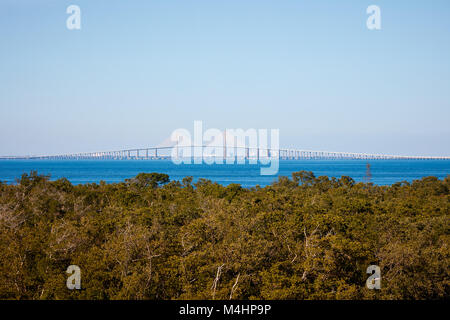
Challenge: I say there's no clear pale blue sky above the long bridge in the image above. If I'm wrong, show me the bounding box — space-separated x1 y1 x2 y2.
0 0 450 155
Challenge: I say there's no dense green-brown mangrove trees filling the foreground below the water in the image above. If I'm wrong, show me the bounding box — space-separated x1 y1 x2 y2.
0 171 450 299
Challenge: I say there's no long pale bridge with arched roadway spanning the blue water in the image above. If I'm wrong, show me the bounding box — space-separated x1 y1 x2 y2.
0 146 450 161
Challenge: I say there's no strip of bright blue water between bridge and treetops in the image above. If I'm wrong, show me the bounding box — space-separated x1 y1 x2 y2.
0 160 450 187
